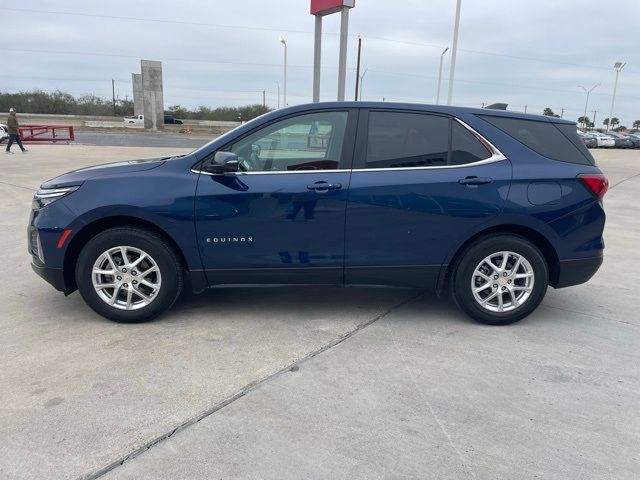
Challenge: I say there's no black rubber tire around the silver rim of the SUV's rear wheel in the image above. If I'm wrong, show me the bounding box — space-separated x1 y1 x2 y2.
451 234 549 325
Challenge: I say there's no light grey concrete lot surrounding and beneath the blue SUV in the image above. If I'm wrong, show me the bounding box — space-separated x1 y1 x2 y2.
0 145 640 479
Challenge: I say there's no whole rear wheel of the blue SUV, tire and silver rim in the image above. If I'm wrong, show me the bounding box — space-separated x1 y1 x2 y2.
452 235 549 325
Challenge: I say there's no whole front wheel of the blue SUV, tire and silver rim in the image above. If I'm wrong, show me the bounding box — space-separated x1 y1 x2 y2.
76 227 183 323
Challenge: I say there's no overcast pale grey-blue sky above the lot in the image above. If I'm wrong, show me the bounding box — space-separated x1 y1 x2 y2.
0 0 640 126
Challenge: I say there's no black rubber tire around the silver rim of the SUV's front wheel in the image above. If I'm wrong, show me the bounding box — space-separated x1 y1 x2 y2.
75 227 184 323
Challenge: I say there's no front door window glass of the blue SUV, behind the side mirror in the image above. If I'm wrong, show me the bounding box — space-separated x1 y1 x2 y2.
225 112 348 172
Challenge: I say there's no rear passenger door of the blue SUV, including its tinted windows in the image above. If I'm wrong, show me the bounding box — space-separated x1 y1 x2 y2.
345 110 511 287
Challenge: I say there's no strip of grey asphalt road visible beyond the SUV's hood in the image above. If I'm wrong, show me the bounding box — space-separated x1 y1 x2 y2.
75 132 213 149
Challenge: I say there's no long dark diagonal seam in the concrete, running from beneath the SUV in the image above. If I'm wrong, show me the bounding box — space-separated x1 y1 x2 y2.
78 291 424 480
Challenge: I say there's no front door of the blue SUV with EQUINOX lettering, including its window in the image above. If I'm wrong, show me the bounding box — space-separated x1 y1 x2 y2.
195 110 356 285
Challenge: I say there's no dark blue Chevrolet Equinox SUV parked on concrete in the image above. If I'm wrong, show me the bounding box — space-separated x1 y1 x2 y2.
28 102 608 325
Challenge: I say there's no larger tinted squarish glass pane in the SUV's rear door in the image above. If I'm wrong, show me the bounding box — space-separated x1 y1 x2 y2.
365 112 449 168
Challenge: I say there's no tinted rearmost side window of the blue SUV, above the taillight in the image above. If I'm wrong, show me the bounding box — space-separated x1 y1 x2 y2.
482 115 595 165
